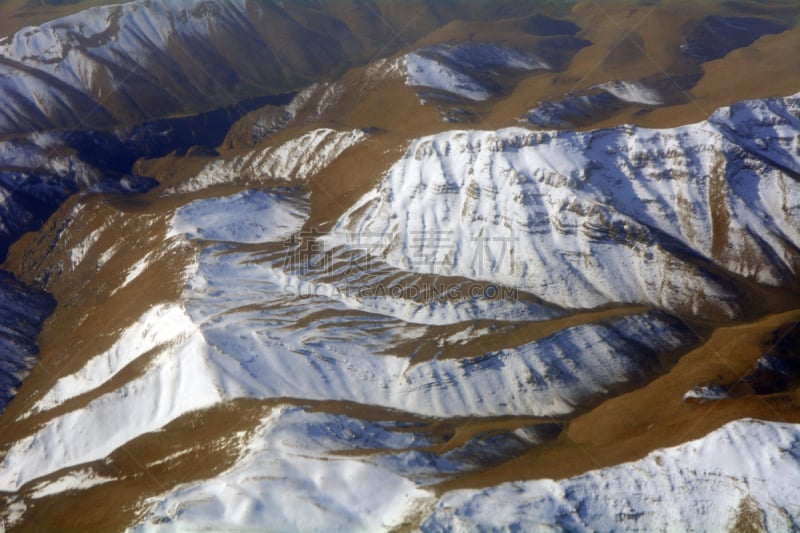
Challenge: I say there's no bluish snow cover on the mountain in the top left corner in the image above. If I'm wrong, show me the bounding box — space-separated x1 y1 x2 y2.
0 0 254 131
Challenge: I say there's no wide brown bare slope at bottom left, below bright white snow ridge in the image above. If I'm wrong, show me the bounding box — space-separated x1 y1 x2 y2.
7 400 275 533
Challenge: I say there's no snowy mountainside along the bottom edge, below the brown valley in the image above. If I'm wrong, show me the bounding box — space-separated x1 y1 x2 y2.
133 416 800 532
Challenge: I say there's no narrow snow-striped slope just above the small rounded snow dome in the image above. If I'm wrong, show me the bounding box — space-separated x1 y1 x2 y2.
168 128 367 193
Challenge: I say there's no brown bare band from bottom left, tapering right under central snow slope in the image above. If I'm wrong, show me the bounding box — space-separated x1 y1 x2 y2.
7 398 564 533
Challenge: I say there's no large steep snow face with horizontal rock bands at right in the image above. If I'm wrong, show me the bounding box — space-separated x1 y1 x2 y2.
327 93 800 316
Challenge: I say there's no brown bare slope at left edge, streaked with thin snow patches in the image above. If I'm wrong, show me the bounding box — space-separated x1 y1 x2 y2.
0 191 194 440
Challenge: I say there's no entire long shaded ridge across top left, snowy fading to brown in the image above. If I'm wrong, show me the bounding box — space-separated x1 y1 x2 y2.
0 0 540 134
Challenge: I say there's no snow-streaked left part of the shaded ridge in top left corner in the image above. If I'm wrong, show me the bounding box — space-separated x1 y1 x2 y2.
0 1 252 132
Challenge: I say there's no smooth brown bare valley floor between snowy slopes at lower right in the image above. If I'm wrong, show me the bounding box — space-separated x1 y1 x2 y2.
439 311 800 491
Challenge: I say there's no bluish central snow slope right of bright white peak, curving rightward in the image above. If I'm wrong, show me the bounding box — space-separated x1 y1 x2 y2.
173 239 693 416
